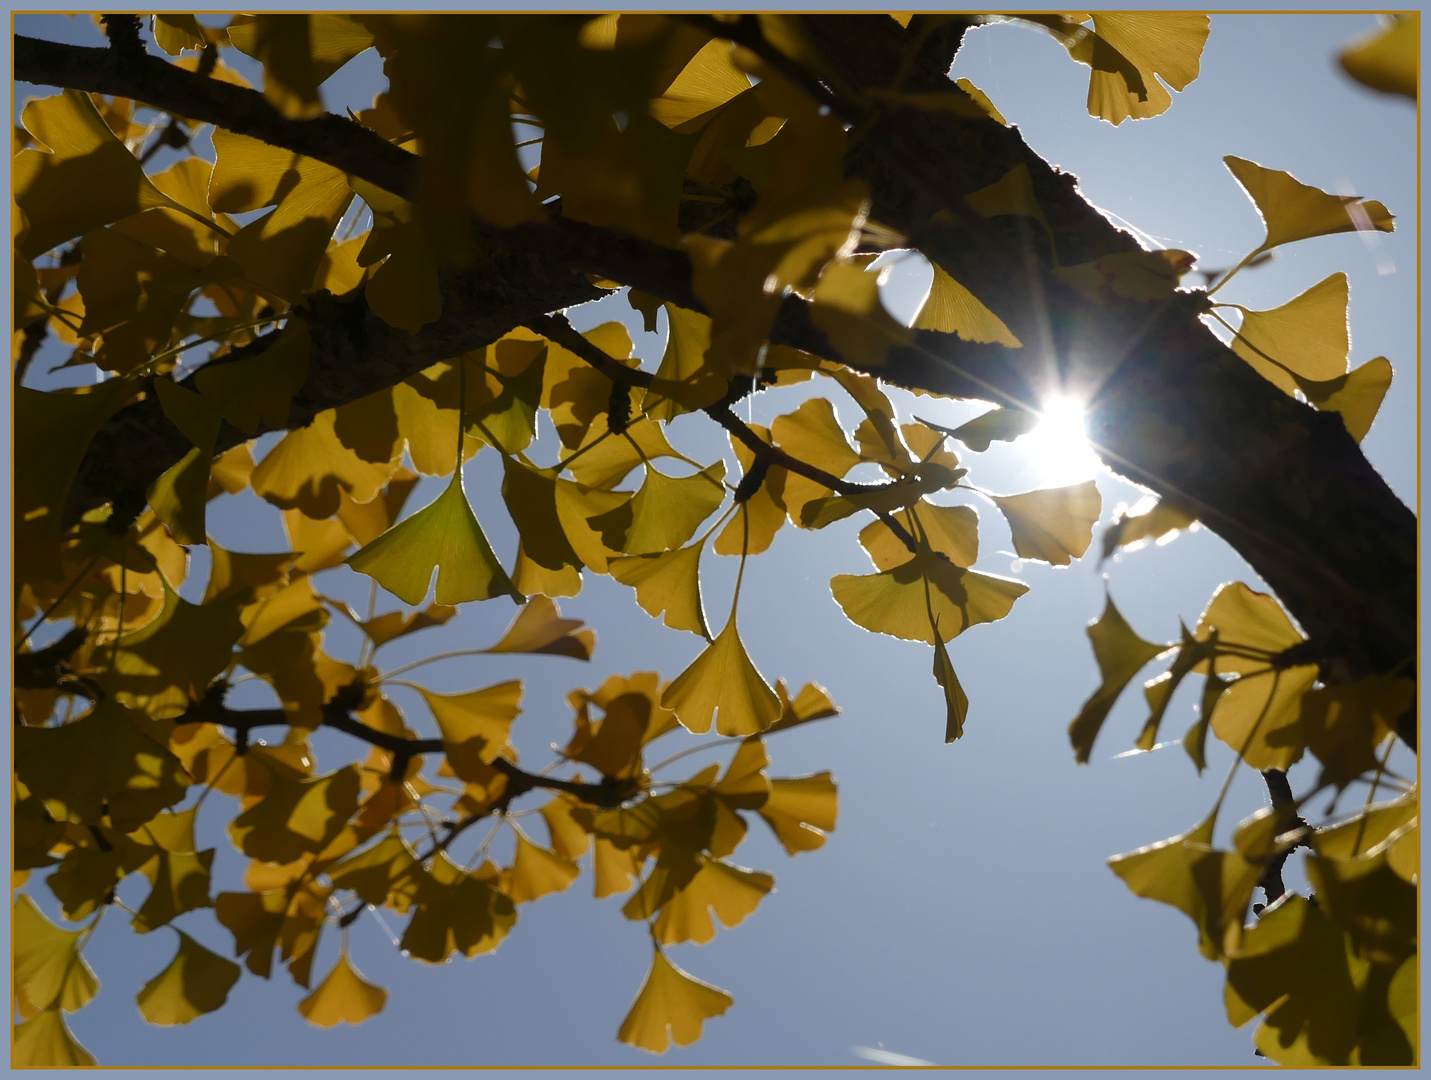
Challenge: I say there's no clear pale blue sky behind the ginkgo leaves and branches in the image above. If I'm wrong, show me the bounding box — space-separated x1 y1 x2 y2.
17 14 1418 1067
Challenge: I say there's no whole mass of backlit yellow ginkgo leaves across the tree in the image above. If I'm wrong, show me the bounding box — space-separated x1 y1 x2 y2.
11 13 1414 1064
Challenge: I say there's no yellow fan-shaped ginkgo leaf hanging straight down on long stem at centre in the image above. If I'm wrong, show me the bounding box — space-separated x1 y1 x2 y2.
661 611 780 735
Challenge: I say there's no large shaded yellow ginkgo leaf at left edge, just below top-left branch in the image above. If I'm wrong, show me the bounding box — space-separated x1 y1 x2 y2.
10 90 179 259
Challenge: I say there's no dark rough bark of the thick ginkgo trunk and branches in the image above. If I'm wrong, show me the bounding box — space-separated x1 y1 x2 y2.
14 16 1417 747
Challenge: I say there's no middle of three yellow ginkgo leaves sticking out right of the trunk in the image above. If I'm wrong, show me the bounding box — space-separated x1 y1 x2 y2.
1232 273 1351 393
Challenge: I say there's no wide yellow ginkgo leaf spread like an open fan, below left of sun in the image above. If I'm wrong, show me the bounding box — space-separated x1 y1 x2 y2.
830 548 1029 645
